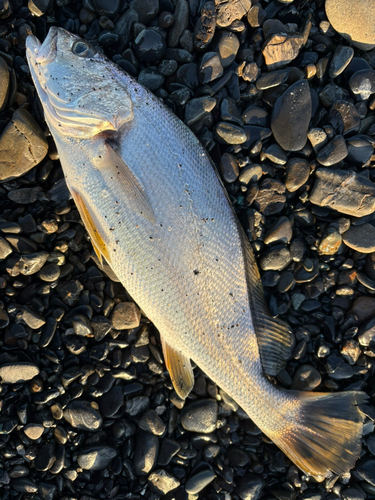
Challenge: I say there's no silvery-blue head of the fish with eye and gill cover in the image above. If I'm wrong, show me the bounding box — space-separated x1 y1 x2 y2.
26 26 134 138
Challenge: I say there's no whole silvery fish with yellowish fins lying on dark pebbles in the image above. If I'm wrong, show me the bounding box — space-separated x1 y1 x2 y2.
26 27 371 481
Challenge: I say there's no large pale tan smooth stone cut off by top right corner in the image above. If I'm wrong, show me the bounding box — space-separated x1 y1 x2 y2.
325 0 375 50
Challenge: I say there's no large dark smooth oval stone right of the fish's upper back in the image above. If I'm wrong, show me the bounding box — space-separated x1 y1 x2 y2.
271 80 312 151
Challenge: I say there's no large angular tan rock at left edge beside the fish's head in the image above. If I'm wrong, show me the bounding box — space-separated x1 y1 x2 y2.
0 108 48 181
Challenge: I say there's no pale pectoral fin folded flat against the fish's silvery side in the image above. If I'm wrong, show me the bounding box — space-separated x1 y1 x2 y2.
99 143 156 224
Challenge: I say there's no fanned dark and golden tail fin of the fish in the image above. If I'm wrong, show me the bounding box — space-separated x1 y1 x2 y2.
269 391 370 481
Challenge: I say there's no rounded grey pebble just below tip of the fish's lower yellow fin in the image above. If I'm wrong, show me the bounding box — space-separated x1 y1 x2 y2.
181 399 218 434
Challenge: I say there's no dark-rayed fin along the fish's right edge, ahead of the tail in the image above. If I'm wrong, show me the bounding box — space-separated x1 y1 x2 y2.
239 224 295 376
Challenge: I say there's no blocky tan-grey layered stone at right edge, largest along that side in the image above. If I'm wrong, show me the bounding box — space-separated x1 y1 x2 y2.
309 168 375 217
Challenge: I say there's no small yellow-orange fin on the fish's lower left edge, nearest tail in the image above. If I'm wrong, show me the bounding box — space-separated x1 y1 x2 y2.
162 340 194 399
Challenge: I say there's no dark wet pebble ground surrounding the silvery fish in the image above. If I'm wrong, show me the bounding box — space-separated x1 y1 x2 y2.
0 0 375 500
